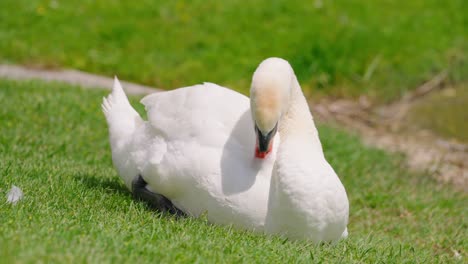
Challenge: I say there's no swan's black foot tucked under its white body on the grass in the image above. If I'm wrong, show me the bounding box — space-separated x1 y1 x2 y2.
132 175 185 216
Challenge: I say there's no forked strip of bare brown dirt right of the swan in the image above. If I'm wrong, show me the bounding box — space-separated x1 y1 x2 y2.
311 72 468 192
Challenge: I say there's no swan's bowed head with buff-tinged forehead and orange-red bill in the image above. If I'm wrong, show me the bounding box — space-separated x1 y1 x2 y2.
250 58 293 158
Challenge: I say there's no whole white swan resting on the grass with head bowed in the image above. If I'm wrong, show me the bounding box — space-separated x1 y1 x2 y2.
102 58 349 242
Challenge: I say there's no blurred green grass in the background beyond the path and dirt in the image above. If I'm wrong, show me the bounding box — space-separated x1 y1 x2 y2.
0 0 468 100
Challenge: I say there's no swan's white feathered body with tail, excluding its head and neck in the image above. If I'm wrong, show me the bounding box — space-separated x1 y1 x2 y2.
102 81 279 229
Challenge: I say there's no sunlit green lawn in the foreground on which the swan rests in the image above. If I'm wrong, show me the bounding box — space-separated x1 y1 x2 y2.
0 80 468 263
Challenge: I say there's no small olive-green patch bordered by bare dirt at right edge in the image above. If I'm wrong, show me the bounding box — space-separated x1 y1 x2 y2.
408 83 468 143
